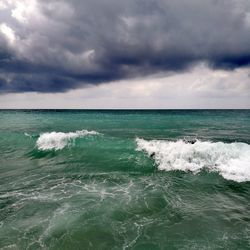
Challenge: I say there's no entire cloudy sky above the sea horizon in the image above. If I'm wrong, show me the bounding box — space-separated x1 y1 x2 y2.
0 0 250 109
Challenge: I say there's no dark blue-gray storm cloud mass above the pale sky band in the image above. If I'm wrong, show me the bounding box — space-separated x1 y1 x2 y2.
0 0 250 93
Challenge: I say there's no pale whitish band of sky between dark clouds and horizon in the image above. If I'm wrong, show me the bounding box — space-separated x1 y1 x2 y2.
0 64 250 109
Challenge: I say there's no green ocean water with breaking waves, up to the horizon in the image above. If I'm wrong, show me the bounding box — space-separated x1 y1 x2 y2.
0 110 250 250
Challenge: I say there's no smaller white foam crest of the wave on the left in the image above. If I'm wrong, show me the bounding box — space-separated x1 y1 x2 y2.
36 130 99 150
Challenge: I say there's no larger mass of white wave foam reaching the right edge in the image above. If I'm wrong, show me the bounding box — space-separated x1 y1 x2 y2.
136 138 250 182
